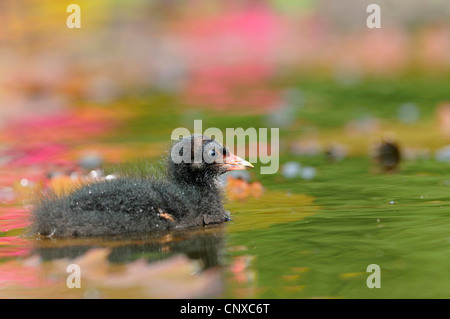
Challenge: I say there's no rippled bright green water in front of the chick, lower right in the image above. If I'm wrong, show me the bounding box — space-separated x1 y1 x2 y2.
228 158 450 298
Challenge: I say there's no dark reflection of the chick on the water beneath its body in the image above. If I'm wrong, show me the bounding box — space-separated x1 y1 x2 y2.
34 225 225 269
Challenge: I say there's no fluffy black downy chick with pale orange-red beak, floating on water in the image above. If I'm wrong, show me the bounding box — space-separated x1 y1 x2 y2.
32 135 253 237
